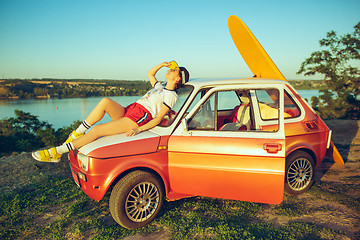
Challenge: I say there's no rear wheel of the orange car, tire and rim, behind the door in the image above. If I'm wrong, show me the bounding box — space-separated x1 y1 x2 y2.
285 151 314 195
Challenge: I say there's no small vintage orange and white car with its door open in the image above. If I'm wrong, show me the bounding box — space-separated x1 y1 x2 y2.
69 15 344 229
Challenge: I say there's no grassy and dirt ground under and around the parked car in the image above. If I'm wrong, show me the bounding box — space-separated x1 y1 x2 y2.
0 120 360 240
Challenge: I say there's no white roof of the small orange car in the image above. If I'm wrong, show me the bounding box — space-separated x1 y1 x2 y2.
186 78 289 88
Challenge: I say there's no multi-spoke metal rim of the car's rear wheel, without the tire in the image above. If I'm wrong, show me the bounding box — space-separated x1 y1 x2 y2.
287 158 313 191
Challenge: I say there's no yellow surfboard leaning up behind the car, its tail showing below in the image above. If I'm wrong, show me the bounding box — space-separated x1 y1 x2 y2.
228 15 344 165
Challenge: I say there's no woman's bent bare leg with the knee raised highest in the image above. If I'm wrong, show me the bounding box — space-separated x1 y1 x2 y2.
86 98 125 125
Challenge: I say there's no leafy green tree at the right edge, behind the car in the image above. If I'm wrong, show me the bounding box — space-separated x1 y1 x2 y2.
298 22 360 119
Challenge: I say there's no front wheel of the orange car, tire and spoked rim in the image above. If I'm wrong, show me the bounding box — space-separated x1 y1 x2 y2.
109 171 164 229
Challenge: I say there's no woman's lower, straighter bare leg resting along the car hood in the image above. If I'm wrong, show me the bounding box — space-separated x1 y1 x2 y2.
72 117 138 148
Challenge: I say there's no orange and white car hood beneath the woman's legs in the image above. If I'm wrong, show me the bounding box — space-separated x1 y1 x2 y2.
79 131 160 158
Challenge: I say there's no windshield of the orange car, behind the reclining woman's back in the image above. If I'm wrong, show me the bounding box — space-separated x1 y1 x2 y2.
159 86 194 127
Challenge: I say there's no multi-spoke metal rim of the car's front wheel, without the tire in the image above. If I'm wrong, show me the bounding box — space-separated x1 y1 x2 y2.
125 182 160 222
